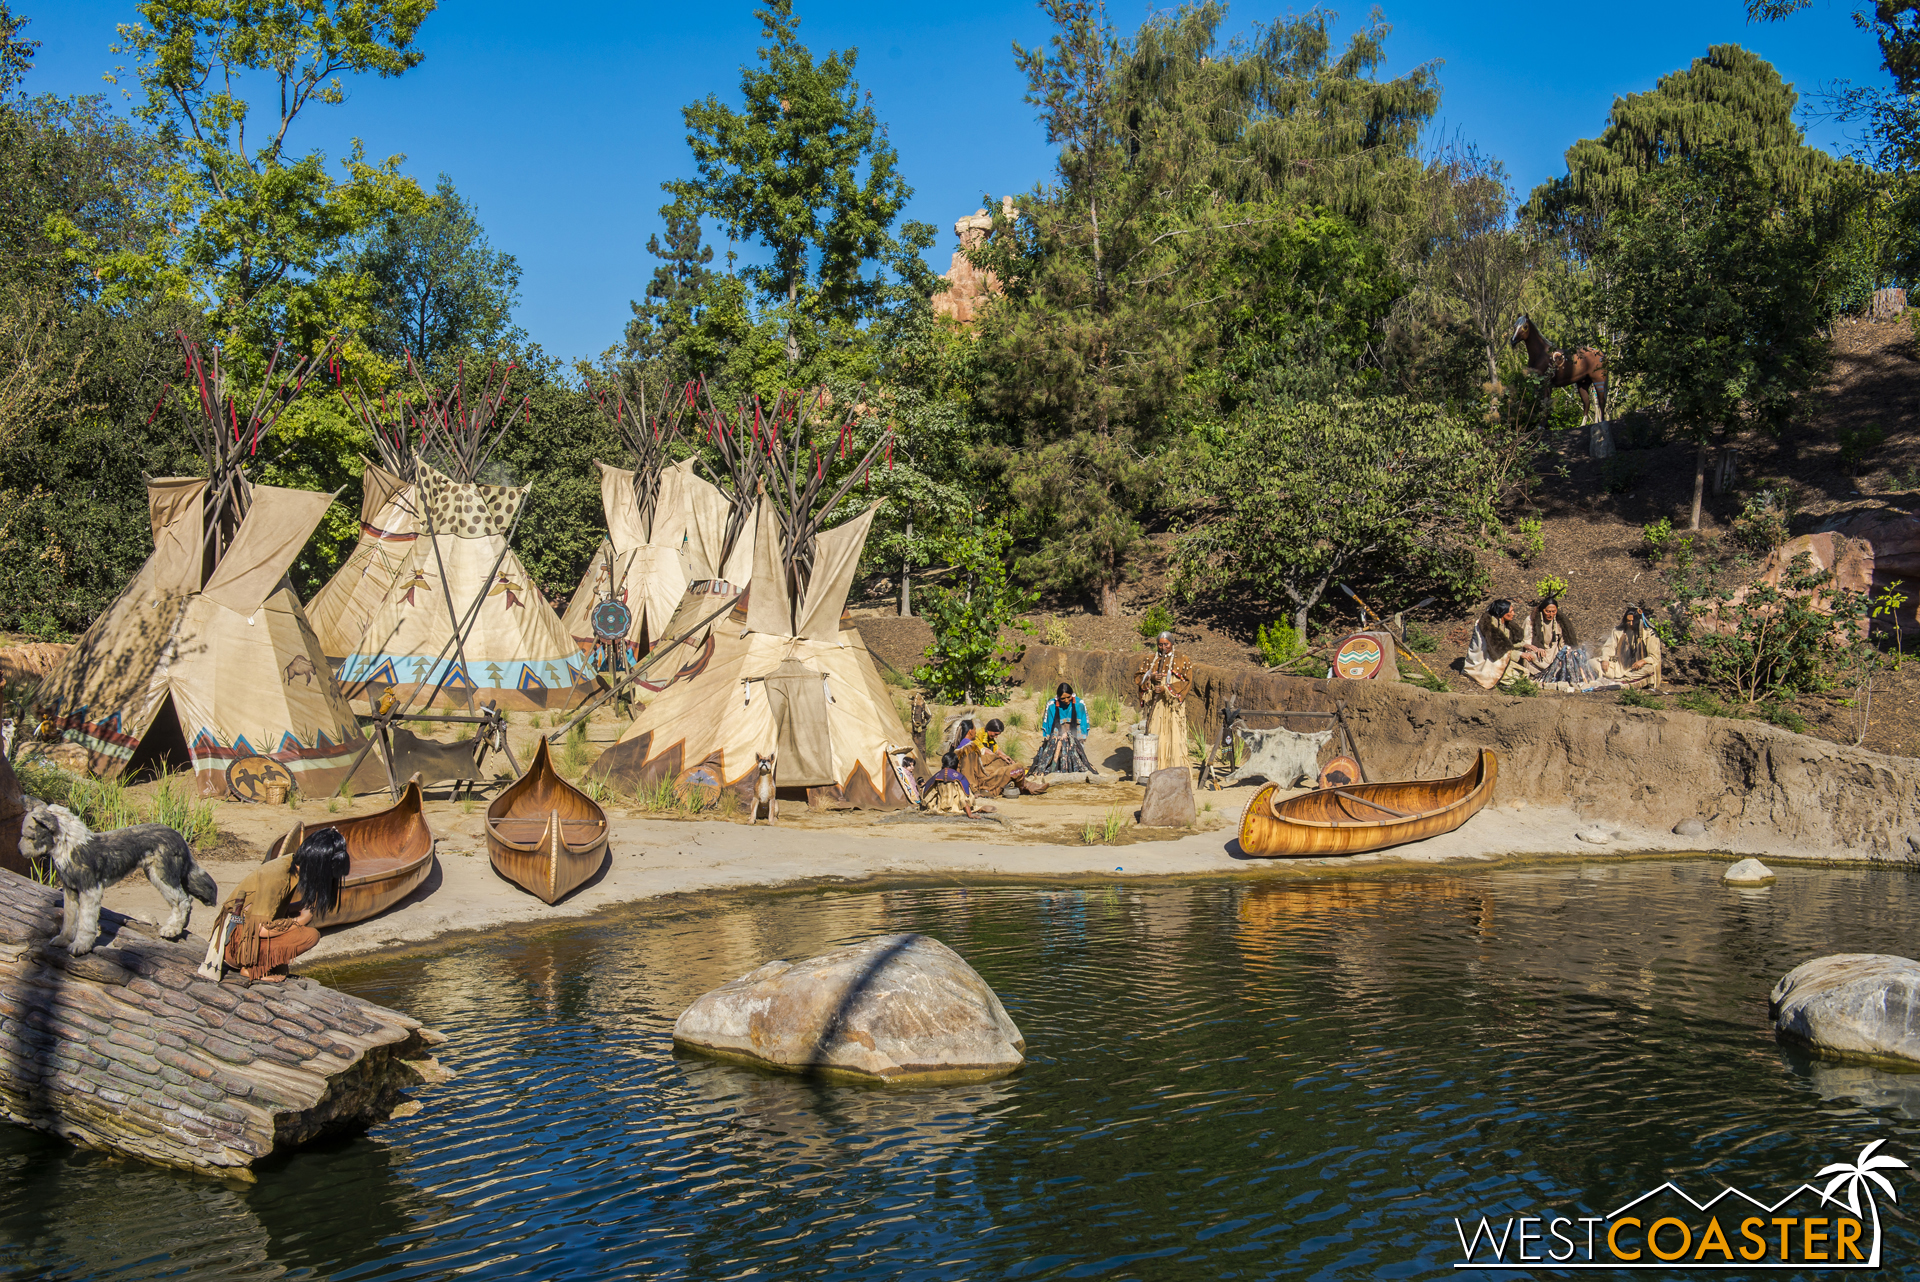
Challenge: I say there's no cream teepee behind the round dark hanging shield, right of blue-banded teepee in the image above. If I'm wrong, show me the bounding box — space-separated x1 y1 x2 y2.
561 383 712 670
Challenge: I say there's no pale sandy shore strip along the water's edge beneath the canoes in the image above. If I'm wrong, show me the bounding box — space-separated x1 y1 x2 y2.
86 785 1870 969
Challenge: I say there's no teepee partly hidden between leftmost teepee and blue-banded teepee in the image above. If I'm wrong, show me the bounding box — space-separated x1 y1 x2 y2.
307 388 420 670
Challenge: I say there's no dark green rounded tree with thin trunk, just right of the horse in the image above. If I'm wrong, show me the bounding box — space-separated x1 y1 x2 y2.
1596 152 1828 530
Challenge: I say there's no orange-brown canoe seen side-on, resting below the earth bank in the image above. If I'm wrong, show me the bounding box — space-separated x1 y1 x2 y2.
1240 748 1500 860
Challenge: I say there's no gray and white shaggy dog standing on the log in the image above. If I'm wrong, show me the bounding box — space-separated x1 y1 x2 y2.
19 806 221 956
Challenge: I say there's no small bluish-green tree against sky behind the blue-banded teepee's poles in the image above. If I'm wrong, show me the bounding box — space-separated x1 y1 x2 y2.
357 175 526 368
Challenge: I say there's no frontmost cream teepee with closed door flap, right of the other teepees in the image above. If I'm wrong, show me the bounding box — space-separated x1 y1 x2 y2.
591 397 912 810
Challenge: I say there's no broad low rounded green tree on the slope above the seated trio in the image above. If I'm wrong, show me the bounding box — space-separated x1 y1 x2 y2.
1175 397 1494 637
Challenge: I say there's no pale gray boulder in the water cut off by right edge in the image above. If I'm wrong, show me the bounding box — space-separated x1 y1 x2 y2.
1768 952 1920 1063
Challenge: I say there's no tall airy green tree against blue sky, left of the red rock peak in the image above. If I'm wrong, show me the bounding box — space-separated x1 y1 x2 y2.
662 0 933 379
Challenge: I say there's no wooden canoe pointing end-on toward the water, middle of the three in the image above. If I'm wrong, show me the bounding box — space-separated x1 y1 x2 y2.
486 735 607 904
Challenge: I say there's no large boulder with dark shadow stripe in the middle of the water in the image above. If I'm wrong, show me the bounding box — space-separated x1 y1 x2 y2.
674 935 1027 1082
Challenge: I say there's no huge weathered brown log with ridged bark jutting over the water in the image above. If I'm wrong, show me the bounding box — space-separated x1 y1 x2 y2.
0 871 451 1176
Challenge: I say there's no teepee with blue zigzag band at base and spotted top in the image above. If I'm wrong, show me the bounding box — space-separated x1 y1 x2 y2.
340 367 593 710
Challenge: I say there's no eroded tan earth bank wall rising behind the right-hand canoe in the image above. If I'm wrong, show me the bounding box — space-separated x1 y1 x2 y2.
1012 645 1920 862
